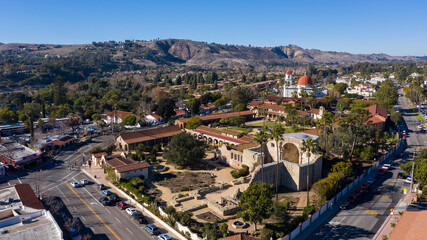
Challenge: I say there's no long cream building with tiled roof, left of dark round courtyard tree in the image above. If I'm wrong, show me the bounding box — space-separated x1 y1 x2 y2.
116 125 182 151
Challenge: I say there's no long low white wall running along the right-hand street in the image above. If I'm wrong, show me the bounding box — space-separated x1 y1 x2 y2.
282 143 404 240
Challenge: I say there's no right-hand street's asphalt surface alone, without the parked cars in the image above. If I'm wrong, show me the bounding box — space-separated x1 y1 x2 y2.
307 92 427 240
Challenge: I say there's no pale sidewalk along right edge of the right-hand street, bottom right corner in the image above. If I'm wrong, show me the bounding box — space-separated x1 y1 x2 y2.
373 187 416 240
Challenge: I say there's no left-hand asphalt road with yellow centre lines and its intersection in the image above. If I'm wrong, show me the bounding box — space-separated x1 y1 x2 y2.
0 136 177 239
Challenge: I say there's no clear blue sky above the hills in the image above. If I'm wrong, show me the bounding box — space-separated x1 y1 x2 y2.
0 0 427 56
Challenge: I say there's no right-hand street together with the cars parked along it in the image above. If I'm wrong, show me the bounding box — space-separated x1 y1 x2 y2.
301 90 427 240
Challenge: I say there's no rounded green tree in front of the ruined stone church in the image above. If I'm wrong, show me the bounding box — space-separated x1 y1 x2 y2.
237 182 273 231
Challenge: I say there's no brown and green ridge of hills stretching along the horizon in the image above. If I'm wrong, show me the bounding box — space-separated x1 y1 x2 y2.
0 39 427 68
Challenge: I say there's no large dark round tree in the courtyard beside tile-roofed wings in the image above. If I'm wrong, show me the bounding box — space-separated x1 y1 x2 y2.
163 133 205 167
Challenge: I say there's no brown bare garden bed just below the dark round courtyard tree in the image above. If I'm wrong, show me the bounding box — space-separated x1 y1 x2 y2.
156 172 215 193
